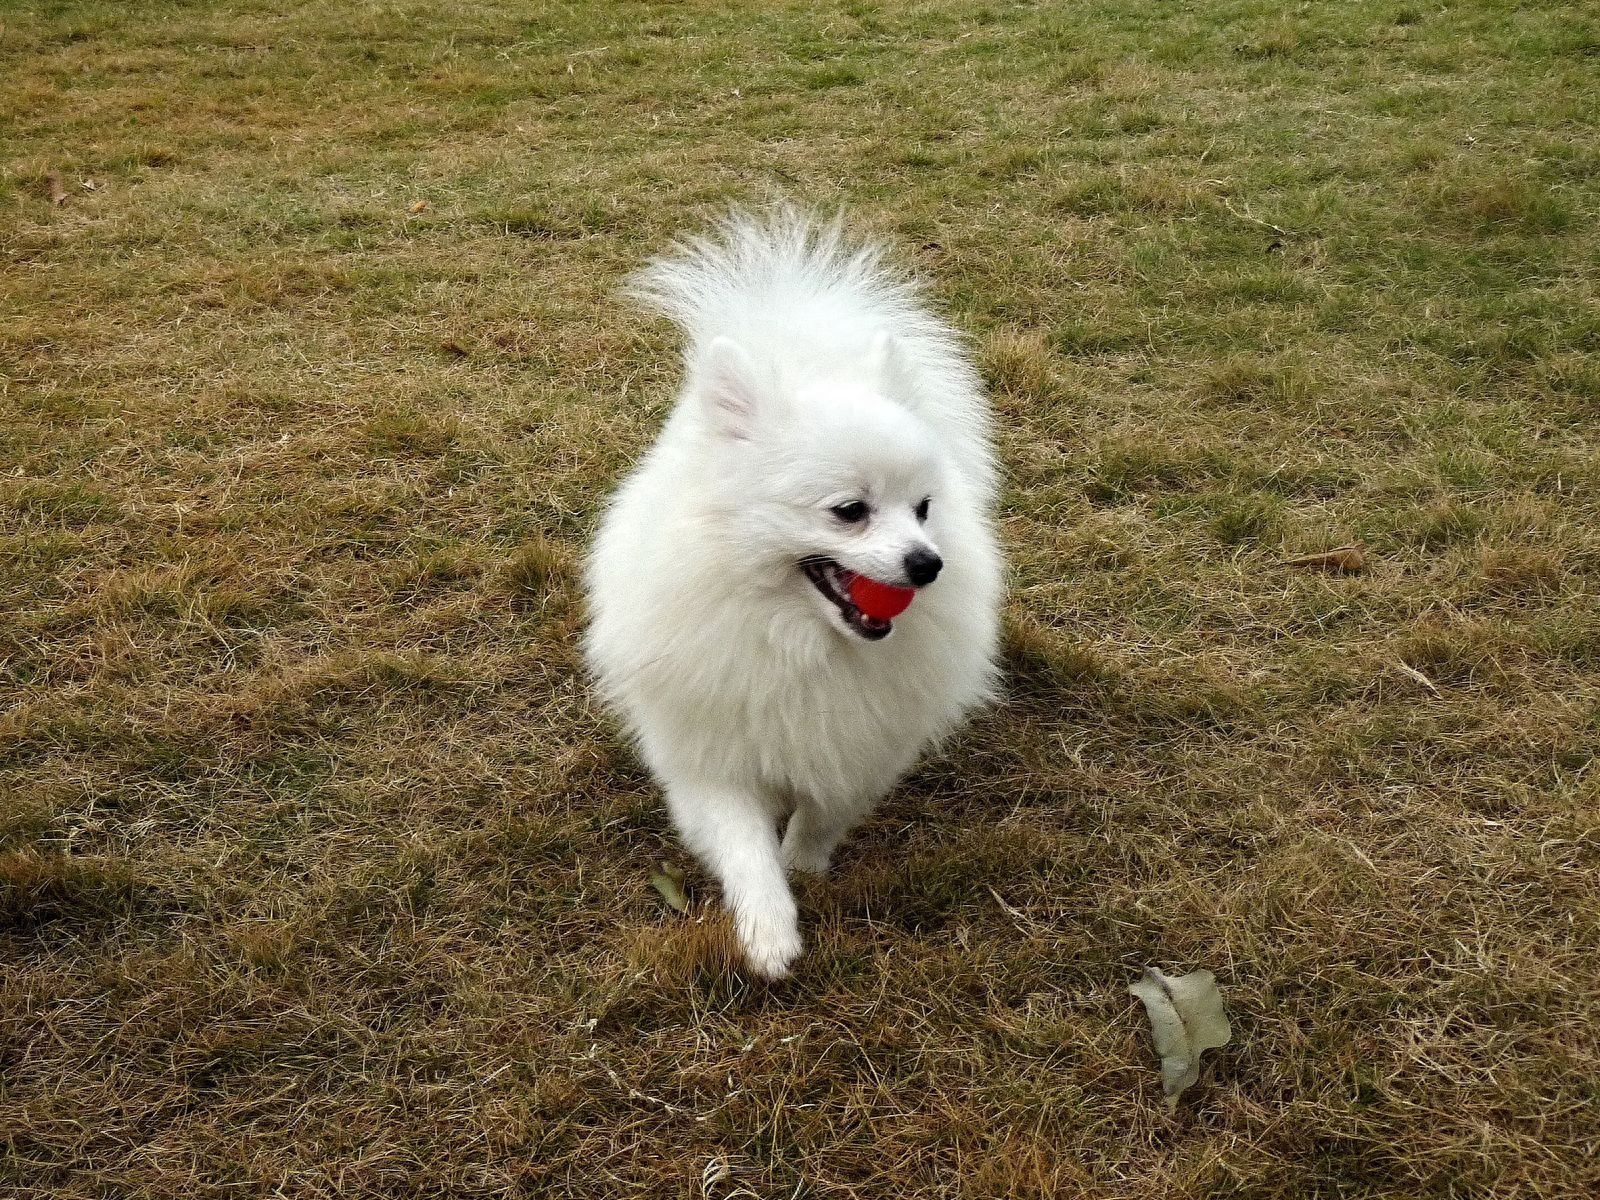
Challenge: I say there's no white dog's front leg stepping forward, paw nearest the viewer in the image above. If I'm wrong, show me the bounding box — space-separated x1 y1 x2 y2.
667 784 800 979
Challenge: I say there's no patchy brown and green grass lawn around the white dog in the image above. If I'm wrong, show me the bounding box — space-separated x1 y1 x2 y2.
0 0 1600 1200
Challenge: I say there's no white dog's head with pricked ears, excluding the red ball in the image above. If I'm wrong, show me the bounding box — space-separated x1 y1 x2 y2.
691 333 949 642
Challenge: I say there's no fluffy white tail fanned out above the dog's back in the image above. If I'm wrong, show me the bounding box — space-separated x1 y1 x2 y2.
627 205 917 342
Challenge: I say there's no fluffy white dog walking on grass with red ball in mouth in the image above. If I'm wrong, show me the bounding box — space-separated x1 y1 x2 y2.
587 210 1002 978
